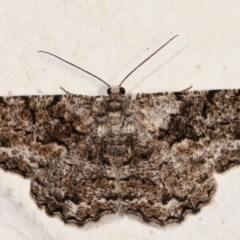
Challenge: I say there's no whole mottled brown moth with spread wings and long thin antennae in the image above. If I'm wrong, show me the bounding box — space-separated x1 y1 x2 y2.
0 36 240 225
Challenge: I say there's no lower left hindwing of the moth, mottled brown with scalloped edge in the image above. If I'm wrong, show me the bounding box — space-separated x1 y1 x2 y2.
31 136 119 225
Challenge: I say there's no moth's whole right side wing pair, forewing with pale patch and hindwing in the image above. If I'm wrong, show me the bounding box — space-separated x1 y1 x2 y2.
121 90 240 225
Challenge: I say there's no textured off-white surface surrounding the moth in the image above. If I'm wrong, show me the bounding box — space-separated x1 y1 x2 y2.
0 0 240 240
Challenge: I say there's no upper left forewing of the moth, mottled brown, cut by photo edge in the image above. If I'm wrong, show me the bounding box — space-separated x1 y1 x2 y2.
0 95 95 177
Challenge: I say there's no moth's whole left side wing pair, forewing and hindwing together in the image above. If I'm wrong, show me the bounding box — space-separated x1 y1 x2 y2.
0 95 118 225
